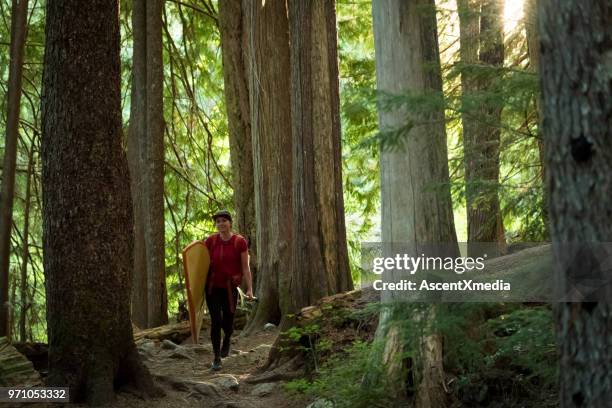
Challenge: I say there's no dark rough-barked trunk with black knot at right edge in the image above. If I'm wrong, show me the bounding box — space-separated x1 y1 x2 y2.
538 0 612 408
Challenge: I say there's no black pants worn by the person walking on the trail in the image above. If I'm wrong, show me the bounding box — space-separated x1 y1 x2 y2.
206 288 238 356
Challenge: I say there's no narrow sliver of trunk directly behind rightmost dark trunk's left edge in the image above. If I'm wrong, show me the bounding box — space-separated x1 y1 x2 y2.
524 0 549 239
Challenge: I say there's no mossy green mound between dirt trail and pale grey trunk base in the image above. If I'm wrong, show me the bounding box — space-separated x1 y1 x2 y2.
284 291 392 408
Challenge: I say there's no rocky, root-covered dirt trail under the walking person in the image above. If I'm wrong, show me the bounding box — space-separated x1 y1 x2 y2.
115 330 310 408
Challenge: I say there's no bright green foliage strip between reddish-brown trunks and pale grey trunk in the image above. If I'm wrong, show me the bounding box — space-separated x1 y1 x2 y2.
336 0 380 281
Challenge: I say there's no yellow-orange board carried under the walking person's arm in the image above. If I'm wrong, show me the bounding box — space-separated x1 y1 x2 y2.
183 241 210 344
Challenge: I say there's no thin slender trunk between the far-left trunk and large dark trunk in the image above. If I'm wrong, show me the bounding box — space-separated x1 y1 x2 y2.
19 145 34 343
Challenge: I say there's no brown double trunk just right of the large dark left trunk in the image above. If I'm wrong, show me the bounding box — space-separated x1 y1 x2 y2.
129 0 168 328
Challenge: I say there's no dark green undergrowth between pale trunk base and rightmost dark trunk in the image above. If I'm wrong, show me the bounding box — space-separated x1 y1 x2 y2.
435 303 558 397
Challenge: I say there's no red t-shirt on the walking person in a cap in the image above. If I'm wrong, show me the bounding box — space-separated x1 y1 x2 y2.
204 234 248 288
